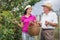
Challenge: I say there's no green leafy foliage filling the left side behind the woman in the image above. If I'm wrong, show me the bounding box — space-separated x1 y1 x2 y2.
0 0 40 40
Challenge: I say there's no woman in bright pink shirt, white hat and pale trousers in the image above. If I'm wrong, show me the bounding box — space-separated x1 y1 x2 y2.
15 5 36 40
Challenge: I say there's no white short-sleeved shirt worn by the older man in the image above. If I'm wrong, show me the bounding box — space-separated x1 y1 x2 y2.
41 11 58 29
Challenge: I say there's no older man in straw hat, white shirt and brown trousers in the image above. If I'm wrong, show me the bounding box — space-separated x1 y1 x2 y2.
41 3 58 40
